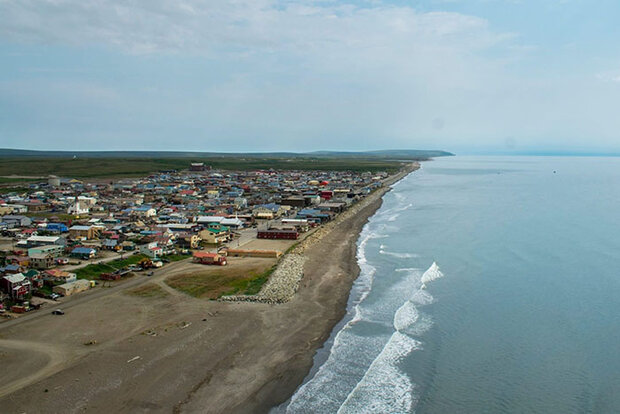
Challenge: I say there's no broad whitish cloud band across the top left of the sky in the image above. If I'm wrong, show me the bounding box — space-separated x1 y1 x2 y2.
0 0 502 54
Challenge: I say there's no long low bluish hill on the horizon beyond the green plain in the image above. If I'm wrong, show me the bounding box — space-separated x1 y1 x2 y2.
0 148 454 160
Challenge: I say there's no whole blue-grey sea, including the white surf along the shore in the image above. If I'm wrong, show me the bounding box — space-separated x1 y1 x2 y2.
277 157 620 413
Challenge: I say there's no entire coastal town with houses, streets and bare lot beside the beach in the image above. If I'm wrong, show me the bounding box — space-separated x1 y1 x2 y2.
0 162 388 320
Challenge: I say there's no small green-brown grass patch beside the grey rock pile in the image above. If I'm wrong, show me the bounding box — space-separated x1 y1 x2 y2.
166 264 275 299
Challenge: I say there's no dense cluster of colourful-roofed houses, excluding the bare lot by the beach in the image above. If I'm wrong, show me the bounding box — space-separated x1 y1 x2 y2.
0 163 387 310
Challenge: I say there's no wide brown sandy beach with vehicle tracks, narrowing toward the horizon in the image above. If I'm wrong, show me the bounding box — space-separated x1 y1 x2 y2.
0 164 417 413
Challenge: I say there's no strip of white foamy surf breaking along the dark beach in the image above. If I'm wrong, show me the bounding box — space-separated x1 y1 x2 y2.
278 180 443 414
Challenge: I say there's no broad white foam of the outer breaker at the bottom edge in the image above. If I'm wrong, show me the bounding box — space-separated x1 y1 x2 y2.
338 332 421 414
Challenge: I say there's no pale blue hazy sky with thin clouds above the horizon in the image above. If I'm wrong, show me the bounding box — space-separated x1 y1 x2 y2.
0 0 620 153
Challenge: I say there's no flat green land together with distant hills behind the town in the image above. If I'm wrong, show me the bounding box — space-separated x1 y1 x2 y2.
0 149 451 178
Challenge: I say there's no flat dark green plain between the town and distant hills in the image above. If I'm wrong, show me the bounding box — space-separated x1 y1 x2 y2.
0 157 400 181
